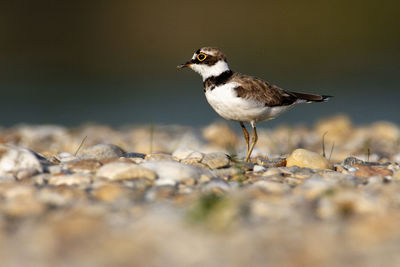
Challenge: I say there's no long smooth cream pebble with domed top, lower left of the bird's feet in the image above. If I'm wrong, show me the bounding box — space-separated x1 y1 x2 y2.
96 162 157 180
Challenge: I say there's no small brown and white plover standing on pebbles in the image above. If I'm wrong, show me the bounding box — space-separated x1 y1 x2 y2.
177 47 332 162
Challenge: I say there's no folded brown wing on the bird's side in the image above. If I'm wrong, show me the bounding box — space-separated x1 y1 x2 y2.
230 73 298 107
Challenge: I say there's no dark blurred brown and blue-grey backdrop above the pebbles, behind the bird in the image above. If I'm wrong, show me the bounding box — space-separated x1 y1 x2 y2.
0 0 400 127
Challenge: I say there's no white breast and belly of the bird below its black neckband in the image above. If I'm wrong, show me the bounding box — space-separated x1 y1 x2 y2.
206 82 293 122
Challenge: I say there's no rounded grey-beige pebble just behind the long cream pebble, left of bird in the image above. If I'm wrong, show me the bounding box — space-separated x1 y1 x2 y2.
77 144 125 160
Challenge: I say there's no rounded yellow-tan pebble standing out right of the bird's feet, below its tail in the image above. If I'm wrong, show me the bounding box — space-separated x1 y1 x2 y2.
286 148 333 169
